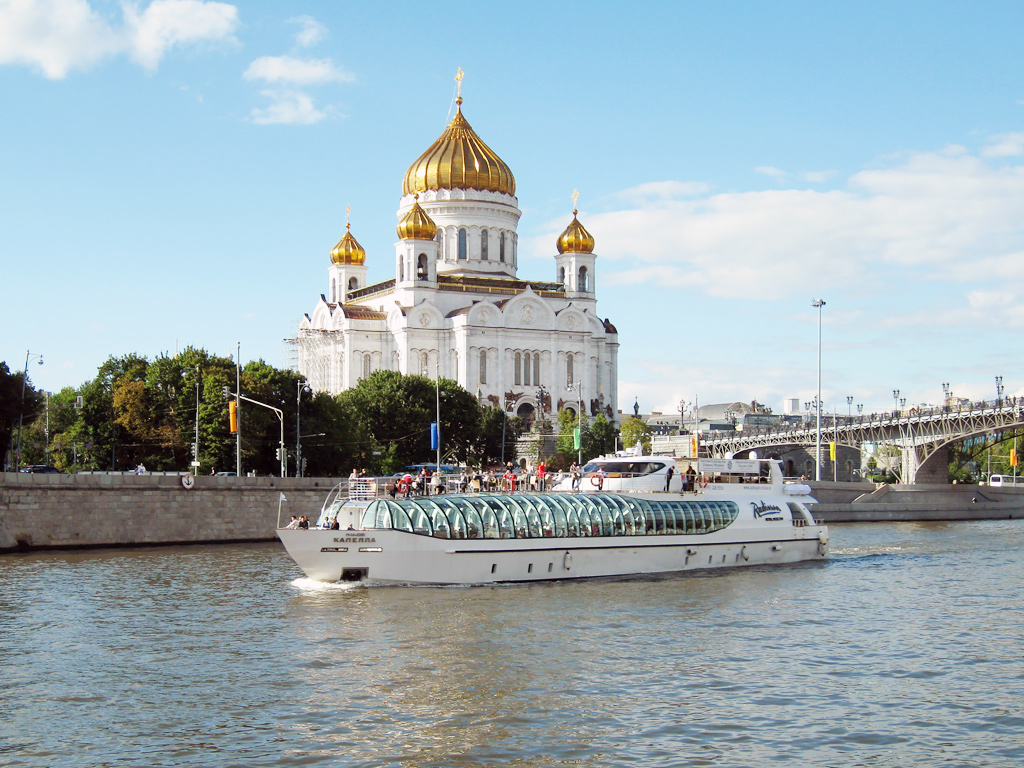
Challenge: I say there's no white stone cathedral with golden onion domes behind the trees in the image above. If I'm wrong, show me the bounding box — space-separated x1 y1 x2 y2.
295 81 618 430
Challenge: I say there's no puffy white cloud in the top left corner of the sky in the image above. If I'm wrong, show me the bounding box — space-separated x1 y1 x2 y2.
0 0 239 80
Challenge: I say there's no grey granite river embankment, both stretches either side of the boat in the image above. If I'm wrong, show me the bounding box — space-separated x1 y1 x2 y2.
0 472 1024 552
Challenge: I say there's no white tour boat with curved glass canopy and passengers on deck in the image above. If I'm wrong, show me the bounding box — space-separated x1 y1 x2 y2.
278 457 828 585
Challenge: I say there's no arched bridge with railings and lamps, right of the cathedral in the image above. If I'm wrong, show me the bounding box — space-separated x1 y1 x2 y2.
655 397 1024 483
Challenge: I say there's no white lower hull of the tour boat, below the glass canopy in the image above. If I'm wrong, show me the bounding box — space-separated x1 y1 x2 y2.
278 525 828 585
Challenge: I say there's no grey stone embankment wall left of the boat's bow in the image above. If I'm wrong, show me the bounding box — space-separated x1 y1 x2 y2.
0 472 348 552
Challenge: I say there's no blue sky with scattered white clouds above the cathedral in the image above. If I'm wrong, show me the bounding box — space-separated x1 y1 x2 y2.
0 0 1024 421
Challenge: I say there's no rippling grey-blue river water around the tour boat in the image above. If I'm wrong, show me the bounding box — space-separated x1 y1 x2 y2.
0 520 1024 768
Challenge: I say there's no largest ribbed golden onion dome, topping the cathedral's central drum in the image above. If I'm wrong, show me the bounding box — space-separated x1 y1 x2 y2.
401 97 515 195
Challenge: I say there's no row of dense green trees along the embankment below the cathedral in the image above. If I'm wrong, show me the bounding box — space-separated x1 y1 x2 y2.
0 347 629 476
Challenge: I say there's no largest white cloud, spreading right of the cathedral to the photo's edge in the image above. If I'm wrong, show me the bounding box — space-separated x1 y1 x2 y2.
537 140 1024 328
